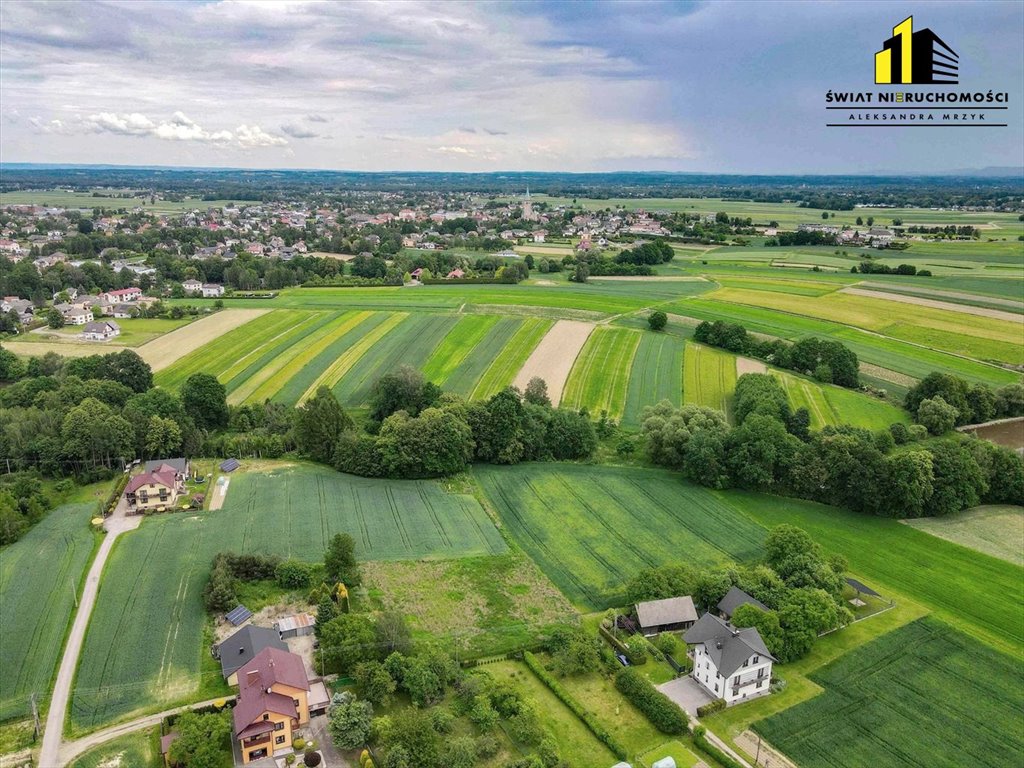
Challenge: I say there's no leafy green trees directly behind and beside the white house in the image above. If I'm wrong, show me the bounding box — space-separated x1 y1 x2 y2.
626 525 853 663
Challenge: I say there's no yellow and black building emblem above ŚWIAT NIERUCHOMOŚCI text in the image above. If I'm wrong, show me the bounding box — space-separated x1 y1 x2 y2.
874 16 959 85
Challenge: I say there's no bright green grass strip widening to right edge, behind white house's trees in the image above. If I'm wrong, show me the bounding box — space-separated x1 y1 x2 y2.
728 492 1024 657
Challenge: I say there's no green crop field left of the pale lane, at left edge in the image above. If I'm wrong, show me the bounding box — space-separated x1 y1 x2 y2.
0 503 97 721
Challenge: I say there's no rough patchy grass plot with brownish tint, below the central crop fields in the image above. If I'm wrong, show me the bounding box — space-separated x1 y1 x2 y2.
362 552 575 656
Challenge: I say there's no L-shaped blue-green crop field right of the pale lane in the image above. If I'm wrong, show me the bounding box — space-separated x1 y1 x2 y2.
71 465 507 731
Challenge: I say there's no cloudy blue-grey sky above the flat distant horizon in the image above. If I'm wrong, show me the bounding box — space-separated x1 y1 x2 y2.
0 0 1024 174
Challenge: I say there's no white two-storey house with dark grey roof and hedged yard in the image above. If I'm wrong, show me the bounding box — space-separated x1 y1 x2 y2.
683 613 776 705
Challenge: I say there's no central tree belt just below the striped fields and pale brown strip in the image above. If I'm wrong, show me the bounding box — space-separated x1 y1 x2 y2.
295 367 597 477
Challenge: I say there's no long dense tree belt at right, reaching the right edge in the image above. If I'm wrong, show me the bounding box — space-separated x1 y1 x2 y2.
642 374 1024 518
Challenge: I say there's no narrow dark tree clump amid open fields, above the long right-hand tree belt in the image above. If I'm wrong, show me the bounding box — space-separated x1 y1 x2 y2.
693 321 860 388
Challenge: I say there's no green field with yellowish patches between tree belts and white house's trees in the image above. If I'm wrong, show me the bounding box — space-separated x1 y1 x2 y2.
473 464 765 610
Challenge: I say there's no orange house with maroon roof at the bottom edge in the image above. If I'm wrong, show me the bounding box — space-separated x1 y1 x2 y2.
231 647 309 765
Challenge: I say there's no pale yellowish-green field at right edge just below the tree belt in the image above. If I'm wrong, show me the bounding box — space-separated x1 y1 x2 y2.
903 505 1024 566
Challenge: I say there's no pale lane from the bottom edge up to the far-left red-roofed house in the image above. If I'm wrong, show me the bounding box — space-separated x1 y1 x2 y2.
39 500 142 768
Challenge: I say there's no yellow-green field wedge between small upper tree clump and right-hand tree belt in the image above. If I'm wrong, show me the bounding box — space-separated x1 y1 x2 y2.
772 371 909 429
